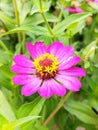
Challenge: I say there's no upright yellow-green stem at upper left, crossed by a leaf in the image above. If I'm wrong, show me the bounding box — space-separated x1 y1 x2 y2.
13 0 21 43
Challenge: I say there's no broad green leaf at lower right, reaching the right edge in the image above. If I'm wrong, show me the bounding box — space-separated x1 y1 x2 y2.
64 101 98 125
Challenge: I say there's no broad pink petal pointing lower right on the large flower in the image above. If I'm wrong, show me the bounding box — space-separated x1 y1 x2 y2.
56 75 81 92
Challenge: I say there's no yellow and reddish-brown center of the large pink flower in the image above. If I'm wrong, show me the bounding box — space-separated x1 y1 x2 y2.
33 53 59 80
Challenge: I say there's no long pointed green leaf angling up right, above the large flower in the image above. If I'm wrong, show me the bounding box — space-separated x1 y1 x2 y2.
53 13 91 35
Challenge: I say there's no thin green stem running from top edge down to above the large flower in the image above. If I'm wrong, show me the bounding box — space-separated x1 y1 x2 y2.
39 0 55 41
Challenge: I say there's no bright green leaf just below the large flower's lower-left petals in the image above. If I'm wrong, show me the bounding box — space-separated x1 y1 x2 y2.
17 97 45 117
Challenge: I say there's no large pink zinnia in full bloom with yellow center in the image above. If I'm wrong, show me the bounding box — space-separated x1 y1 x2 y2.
11 42 85 98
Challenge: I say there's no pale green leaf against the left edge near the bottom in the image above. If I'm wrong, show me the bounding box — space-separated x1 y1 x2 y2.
0 91 16 121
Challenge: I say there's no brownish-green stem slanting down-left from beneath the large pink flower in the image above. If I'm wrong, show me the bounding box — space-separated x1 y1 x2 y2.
43 91 72 125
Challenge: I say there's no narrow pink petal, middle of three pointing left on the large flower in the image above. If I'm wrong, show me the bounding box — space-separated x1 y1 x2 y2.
11 64 35 74
